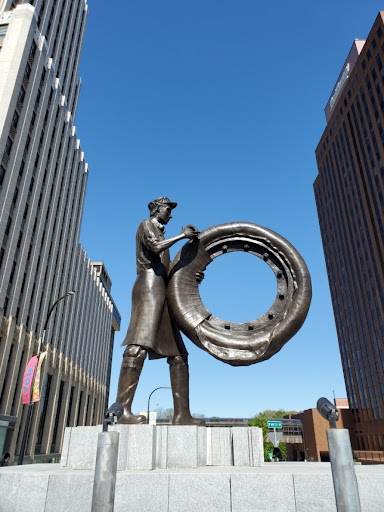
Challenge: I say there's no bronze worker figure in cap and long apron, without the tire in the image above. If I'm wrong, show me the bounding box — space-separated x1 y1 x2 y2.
116 197 204 425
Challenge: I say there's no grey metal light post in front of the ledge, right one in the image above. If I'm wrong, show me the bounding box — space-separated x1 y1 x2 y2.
327 428 361 512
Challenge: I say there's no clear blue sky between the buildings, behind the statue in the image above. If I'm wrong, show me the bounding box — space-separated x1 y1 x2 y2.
76 0 382 417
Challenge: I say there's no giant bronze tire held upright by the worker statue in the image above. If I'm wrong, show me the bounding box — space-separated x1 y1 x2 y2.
167 222 312 366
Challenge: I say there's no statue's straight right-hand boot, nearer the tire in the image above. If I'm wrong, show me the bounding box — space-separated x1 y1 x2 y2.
168 356 205 426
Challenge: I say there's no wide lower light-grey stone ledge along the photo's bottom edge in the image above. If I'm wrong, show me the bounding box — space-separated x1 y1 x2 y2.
0 462 384 512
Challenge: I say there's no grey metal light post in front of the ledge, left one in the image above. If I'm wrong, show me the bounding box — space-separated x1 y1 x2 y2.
91 432 119 512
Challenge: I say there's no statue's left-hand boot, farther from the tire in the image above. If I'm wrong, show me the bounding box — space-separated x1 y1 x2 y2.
116 357 147 425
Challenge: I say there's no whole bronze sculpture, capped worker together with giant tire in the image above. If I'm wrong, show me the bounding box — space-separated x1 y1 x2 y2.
117 197 312 425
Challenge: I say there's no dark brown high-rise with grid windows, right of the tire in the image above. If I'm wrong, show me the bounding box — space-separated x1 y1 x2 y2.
314 12 384 460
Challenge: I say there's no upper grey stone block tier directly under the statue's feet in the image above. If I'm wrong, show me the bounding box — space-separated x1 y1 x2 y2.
61 425 264 471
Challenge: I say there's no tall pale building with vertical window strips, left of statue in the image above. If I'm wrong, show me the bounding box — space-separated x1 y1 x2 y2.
0 0 120 458
